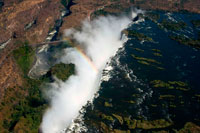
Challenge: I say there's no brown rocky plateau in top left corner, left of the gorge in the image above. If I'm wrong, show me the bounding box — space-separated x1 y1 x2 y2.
0 0 64 43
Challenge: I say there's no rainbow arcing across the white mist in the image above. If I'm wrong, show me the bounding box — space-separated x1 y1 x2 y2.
63 37 98 73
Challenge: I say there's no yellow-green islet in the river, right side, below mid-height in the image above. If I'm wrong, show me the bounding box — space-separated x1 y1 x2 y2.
150 80 189 91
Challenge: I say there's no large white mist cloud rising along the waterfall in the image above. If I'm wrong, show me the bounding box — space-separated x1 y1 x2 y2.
41 13 134 133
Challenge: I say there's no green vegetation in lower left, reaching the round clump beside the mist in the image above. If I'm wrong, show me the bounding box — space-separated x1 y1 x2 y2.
0 42 74 133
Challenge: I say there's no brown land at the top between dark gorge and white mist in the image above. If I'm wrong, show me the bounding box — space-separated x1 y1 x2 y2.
60 0 130 32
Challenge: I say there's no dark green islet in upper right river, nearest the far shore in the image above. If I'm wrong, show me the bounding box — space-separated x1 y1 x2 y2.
161 19 187 30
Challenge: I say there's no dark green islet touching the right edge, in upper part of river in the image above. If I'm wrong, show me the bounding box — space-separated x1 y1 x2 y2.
169 35 200 49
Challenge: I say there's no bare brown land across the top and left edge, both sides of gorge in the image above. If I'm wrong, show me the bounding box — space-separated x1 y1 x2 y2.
0 0 200 131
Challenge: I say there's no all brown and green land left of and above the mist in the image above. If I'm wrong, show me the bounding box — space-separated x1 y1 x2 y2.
0 0 200 132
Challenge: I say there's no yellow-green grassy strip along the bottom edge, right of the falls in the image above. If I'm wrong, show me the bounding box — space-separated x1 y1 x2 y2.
85 107 200 133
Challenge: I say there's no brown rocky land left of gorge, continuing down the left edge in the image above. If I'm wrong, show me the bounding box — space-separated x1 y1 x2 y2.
0 0 65 98
